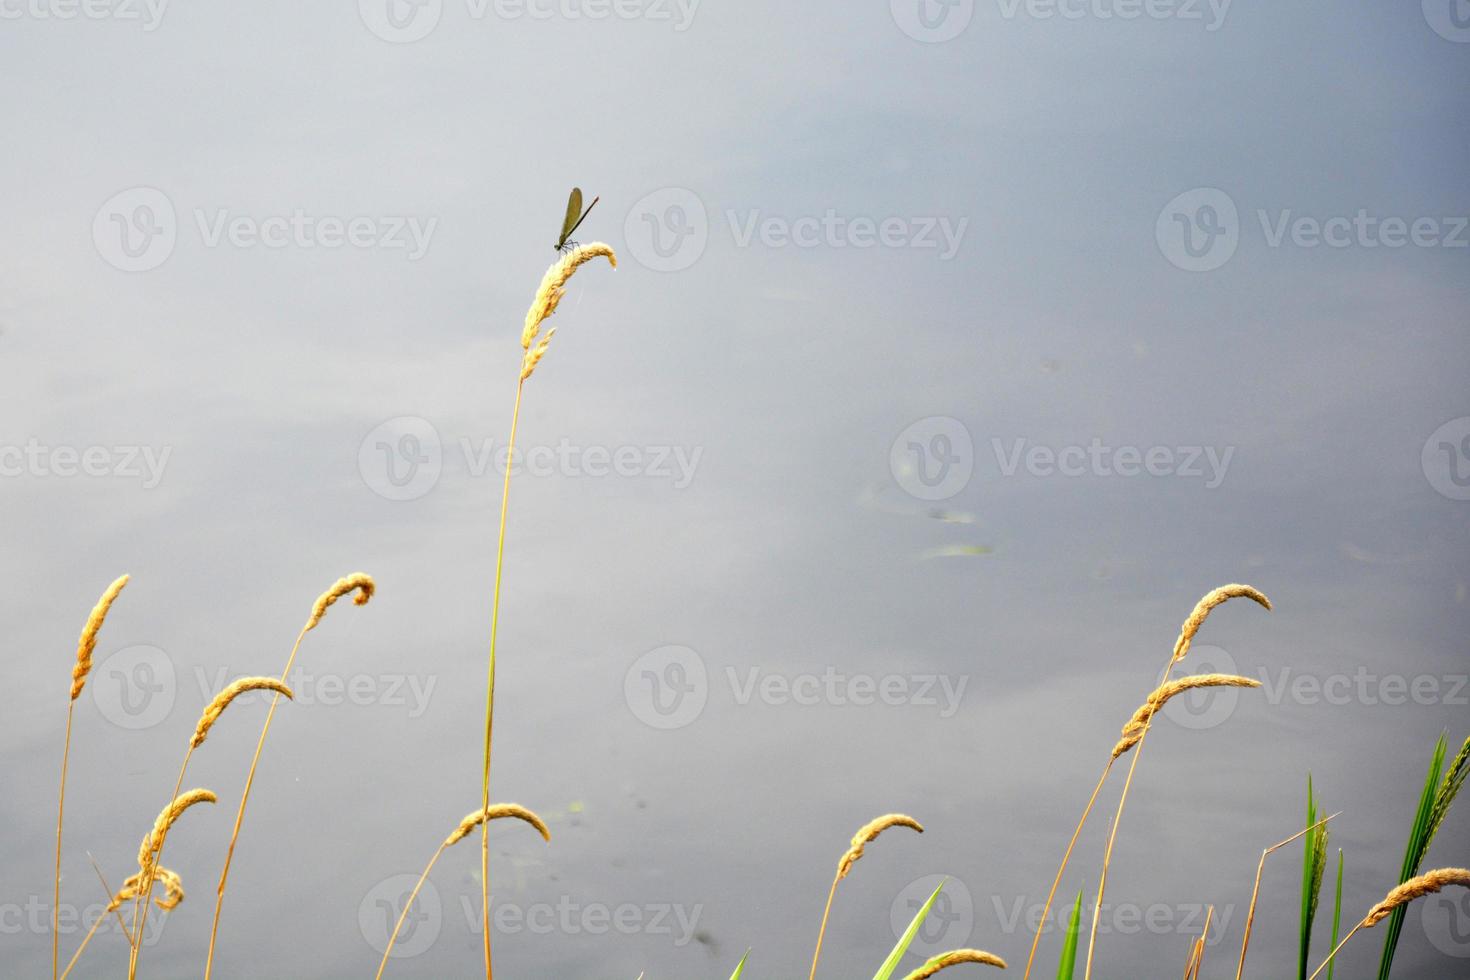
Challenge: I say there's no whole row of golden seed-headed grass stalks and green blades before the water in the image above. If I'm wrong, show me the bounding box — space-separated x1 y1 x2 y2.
40 242 1470 980
